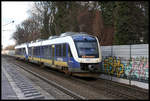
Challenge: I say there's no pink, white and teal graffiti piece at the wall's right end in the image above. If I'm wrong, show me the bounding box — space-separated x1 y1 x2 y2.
125 57 149 80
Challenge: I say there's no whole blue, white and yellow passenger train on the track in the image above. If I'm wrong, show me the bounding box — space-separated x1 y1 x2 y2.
14 32 102 78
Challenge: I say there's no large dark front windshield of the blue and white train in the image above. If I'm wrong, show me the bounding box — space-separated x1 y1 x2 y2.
75 41 99 58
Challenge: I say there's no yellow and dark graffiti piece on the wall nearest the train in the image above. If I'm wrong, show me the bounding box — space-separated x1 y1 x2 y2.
104 57 124 77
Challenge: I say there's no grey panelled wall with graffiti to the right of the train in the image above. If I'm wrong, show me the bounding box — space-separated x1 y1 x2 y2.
101 44 149 83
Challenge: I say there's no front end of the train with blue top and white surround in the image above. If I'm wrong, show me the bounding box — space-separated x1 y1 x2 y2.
69 35 102 77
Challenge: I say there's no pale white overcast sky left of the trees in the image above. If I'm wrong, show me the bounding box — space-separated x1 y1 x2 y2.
1 1 33 48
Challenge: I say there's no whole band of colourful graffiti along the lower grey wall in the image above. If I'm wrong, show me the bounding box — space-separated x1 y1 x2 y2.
103 57 149 81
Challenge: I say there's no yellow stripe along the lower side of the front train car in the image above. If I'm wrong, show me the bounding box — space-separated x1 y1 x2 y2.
29 57 68 67
